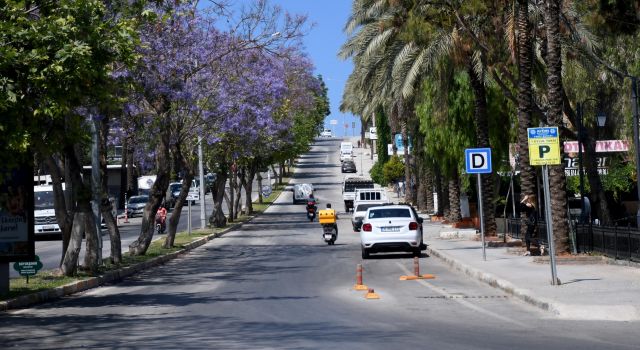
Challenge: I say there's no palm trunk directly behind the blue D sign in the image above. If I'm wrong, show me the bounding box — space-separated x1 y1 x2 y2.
468 61 497 236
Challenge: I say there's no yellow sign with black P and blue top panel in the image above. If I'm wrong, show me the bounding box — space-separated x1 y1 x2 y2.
527 127 561 165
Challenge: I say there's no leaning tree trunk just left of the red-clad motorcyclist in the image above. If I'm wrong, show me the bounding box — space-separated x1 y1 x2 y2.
129 125 171 255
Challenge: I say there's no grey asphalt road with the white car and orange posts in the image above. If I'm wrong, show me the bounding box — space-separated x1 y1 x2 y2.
0 139 640 349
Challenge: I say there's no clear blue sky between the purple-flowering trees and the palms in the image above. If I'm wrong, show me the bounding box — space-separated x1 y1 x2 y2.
270 0 360 136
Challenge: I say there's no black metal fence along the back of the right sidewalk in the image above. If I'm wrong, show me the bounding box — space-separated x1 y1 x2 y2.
507 218 640 262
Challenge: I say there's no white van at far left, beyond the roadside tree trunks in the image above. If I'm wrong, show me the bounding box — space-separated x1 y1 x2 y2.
33 184 64 238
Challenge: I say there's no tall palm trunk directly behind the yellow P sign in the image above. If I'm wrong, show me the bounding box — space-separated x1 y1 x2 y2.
544 0 569 253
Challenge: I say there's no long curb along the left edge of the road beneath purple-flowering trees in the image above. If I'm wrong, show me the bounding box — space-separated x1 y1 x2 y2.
0 185 284 312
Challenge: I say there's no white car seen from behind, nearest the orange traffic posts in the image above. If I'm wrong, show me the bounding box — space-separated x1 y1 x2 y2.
360 204 426 259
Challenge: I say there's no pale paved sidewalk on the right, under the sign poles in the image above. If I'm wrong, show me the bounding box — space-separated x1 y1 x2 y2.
424 220 640 321
